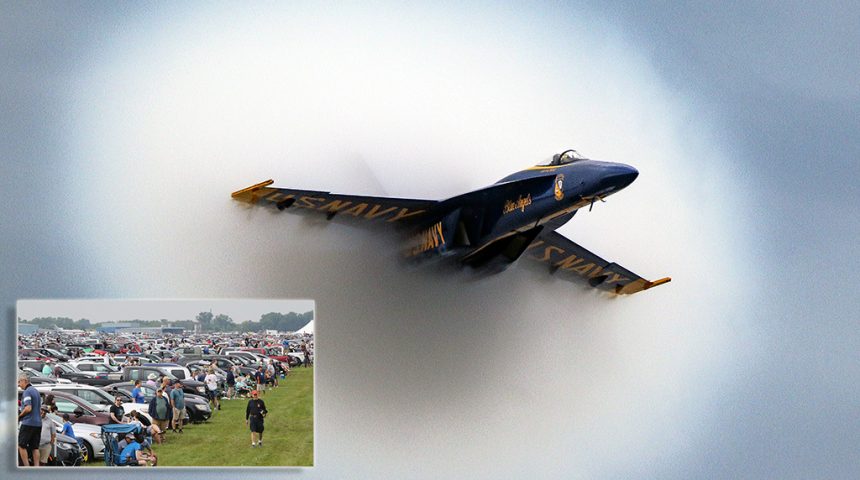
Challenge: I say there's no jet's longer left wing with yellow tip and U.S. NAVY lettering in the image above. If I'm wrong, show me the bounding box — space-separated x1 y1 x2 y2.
232 180 439 225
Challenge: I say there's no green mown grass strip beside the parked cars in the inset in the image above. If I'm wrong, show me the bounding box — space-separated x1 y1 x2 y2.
145 367 314 467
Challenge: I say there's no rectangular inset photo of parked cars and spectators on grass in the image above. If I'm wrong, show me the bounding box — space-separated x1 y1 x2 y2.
15 299 316 468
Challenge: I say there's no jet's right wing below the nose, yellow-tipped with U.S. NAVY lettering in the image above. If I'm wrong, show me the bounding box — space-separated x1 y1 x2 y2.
523 231 672 295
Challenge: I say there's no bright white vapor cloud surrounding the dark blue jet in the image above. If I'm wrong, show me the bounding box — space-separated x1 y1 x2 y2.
65 5 759 478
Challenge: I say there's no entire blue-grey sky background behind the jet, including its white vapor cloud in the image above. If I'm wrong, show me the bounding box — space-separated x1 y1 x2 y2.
0 0 860 479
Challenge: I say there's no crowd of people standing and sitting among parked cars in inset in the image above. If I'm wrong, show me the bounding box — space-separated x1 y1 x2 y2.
18 330 312 466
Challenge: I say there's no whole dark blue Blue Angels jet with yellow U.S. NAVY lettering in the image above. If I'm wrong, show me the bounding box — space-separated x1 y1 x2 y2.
232 150 671 294
